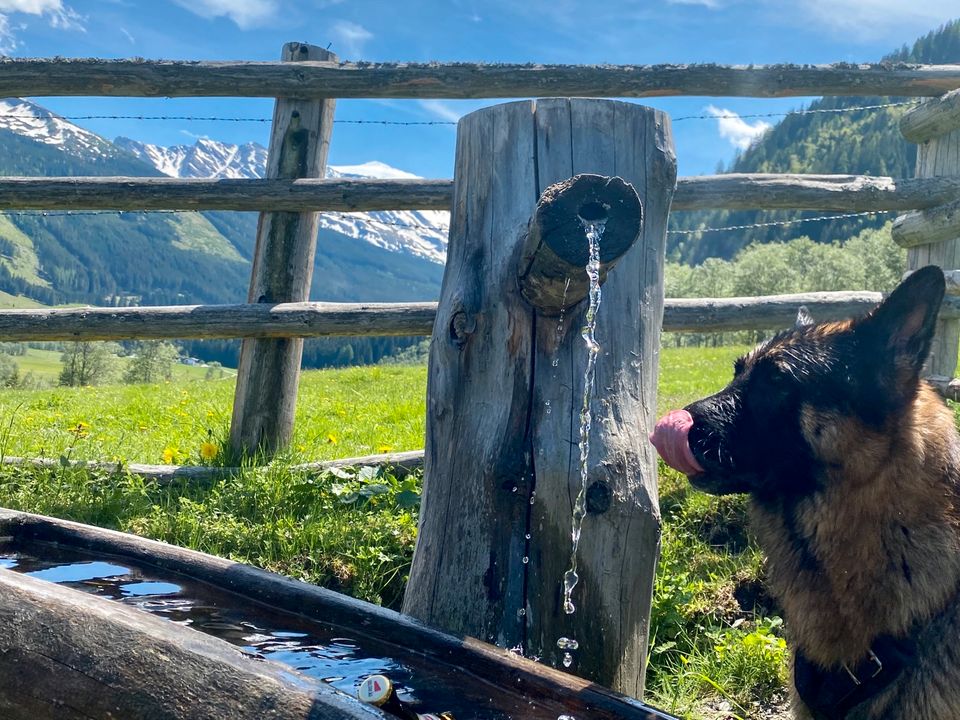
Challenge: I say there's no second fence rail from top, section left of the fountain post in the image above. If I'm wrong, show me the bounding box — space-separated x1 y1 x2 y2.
0 177 453 212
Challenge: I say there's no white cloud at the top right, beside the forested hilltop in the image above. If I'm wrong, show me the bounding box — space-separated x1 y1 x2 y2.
788 0 960 40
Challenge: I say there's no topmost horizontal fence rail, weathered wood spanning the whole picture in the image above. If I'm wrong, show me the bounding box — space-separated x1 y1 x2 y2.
0 58 960 99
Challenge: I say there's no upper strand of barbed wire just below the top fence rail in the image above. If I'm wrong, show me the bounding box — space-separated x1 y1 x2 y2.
0 100 923 126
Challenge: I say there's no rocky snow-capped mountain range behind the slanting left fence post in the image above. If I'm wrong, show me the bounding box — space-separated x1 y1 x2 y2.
114 138 450 264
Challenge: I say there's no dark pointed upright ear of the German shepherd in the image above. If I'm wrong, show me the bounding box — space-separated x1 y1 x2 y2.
855 265 946 383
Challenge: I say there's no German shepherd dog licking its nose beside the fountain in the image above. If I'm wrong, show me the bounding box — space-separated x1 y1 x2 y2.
651 267 960 720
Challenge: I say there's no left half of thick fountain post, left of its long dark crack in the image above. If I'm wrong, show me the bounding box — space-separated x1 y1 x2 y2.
403 101 537 647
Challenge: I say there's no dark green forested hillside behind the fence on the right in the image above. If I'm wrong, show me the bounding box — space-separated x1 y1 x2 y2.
667 20 960 264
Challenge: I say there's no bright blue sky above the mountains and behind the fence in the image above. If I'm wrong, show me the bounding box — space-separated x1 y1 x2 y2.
0 0 960 177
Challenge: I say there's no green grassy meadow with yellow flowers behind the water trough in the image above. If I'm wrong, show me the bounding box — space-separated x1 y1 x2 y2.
0 347 787 718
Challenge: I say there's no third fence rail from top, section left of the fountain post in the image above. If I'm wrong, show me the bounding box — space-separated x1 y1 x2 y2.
0 302 437 342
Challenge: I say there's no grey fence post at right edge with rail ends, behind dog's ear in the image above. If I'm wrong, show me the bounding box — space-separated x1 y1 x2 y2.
893 93 960 385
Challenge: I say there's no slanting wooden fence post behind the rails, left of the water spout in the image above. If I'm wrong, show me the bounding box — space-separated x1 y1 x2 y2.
230 43 337 455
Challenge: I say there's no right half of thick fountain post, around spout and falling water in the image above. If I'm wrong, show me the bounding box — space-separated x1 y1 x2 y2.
528 100 676 696
